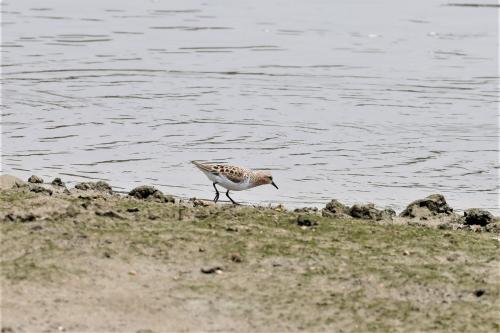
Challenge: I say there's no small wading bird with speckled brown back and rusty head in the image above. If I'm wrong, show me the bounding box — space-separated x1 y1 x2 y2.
192 161 278 205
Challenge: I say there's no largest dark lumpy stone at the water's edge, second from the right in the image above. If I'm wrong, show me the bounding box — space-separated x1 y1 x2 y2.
399 194 453 219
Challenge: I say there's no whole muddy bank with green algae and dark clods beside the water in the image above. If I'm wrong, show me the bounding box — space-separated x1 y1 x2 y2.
0 176 500 332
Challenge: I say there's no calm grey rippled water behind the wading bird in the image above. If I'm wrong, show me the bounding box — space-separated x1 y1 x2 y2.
1 0 499 214
